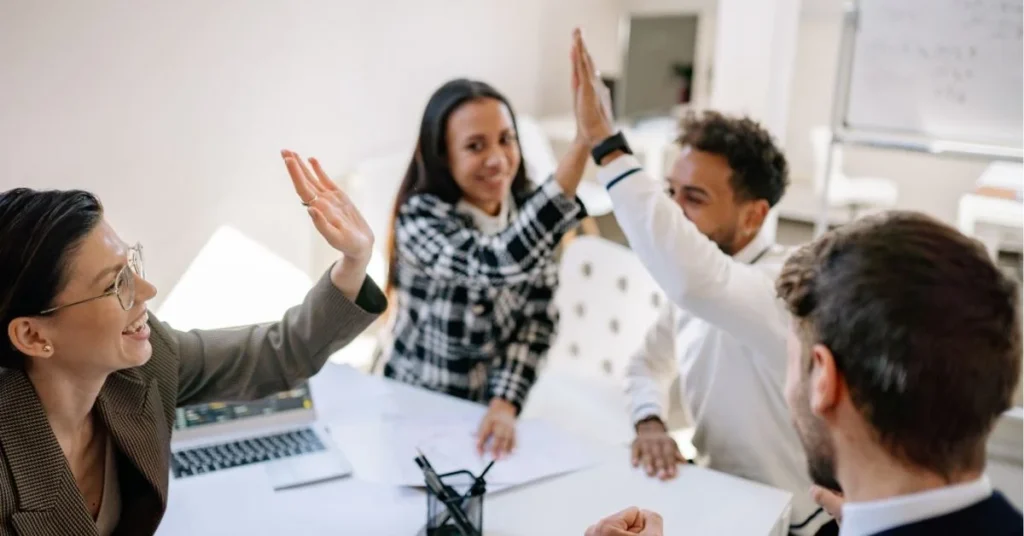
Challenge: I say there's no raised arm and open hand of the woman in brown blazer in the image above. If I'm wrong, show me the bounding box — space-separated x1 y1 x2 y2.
169 151 387 405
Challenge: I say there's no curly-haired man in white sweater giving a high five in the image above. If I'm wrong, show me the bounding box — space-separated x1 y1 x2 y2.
577 30 837 535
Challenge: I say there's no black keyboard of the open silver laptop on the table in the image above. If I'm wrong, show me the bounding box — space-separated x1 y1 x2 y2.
171 428 324 479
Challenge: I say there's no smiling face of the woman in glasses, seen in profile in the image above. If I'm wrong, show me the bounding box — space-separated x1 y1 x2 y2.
10 220 157 374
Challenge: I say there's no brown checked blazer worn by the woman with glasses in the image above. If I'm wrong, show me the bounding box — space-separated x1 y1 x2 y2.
0 275 386 536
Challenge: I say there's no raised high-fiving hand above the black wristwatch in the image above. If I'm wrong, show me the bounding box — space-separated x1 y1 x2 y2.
571 28 615 148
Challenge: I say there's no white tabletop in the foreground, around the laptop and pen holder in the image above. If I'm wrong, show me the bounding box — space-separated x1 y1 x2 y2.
158 364 791 536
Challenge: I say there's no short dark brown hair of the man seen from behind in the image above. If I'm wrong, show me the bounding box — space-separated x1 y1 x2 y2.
776 211 1021 478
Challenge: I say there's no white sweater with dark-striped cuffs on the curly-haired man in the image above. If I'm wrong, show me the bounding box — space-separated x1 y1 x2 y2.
598 156 829 534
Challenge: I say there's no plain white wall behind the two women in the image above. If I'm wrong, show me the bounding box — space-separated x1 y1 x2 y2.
0 0 617 315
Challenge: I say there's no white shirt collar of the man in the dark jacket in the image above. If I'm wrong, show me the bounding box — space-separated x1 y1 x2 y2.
840 477 992 536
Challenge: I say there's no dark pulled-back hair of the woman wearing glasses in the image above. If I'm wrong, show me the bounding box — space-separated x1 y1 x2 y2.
0 188 103 368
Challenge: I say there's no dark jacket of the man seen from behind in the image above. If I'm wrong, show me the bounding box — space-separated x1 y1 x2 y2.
877 492 1024 536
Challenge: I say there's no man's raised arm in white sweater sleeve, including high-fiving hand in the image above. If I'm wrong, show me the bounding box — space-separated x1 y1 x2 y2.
572 32 788 348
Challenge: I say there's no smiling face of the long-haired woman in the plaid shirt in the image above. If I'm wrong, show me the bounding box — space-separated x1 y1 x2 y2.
445 97 521 214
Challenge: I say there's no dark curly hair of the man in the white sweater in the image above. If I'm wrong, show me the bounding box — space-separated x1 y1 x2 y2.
676 111 790 206
